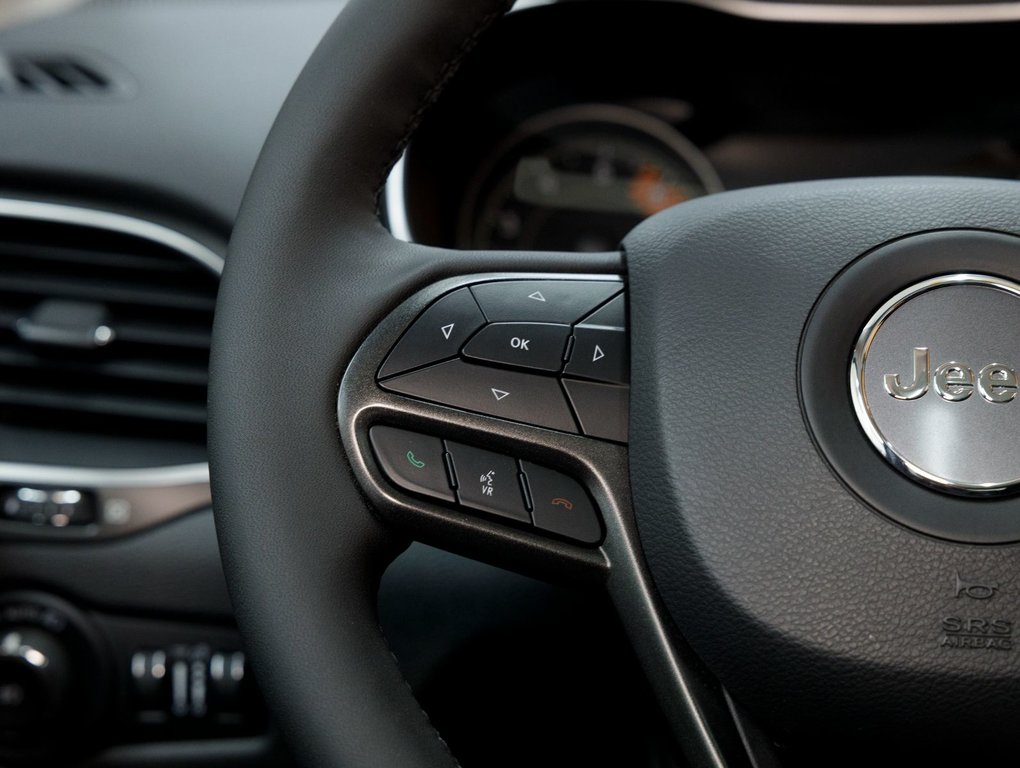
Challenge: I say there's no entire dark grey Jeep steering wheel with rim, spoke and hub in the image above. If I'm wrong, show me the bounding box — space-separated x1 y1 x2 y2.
210 0 1020 768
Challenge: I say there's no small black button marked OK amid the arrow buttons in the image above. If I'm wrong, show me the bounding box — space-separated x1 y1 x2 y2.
463 322 570 371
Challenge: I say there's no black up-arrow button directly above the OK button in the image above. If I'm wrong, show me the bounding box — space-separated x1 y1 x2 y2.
471 280 623 323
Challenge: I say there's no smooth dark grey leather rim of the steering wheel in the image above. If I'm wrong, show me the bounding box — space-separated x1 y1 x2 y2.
210 0 514 768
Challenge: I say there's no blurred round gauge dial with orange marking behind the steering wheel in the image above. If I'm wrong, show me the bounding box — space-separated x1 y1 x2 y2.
457 104 722 252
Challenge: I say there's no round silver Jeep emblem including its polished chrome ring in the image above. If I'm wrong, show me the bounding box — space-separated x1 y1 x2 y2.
848 273 1020 497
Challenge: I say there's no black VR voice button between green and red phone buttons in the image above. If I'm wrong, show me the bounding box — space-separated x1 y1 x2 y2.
447 441 531 522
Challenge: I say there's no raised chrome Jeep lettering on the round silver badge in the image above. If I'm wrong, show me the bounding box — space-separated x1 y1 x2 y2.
882 347 1017 403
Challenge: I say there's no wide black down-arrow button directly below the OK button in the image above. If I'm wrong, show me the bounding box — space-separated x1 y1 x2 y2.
383 360 577 432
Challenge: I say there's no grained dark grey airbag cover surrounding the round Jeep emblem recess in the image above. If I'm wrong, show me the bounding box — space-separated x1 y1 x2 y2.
624 178 1020 748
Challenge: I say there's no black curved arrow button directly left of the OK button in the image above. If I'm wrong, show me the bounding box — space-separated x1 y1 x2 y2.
378 288 486 378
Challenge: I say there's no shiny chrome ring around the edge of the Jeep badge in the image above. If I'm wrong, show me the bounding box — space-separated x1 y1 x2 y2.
850 272 1020 496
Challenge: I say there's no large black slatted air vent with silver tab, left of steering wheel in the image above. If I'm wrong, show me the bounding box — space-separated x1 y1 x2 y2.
0 204 219 443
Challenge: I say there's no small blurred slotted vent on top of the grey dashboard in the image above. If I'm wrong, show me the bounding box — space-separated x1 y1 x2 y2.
0 55 115 98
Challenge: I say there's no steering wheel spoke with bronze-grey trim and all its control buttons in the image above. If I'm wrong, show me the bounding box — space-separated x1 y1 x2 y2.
337 249 746 766
